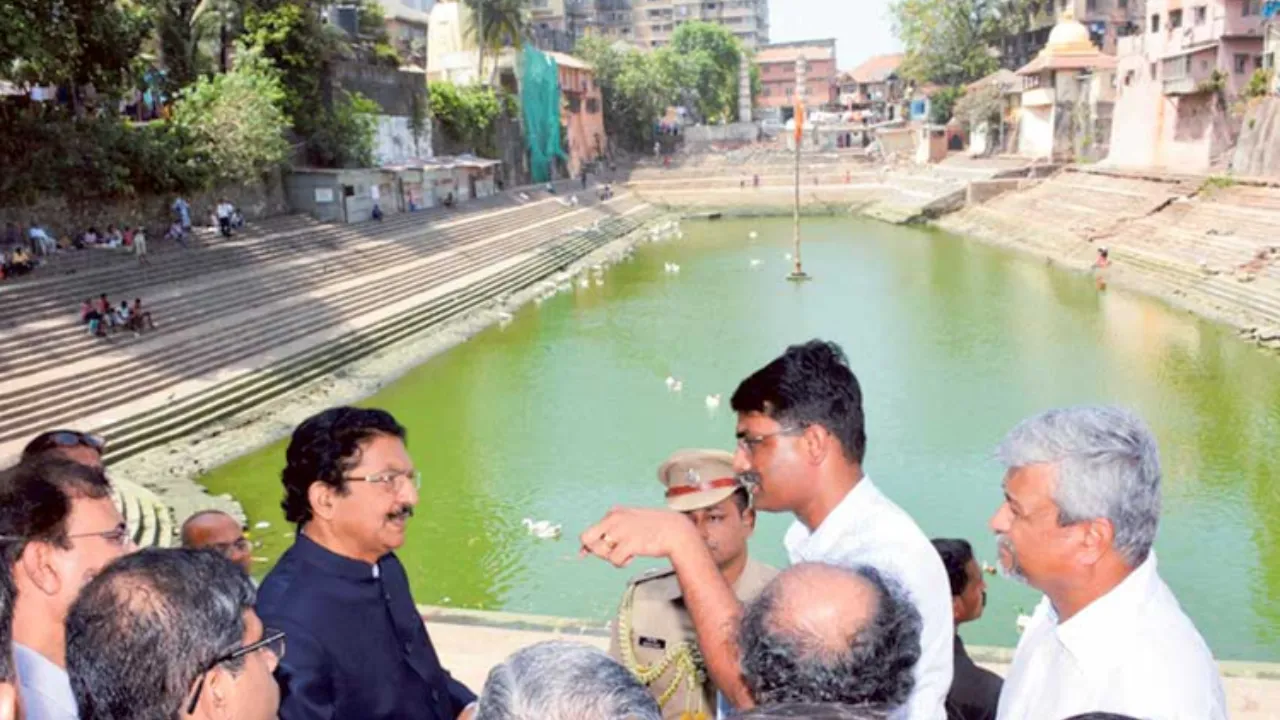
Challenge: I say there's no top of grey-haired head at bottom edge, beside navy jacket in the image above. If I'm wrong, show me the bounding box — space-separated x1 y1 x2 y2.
476 641 662 720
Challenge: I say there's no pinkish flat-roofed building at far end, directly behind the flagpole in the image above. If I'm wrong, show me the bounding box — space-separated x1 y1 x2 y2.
755 40 840 118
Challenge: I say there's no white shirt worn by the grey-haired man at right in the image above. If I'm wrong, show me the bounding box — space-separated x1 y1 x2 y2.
997 552 1226 720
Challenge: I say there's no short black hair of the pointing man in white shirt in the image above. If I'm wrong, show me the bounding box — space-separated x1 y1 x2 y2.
730 340 867 462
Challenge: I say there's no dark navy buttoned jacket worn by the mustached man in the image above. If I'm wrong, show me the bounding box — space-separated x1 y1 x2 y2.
257 533 475 720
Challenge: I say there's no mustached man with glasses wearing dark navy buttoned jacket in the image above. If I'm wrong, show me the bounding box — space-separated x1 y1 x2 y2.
257 407 475 720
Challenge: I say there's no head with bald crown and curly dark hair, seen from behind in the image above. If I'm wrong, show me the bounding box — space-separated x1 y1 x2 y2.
739 564 920 708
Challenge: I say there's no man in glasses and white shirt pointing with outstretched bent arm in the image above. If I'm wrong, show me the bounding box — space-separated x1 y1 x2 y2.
580 340 955 720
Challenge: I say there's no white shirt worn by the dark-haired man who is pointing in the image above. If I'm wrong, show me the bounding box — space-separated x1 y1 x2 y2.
783 477 955 720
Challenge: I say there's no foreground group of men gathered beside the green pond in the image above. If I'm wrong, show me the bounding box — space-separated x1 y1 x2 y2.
0 341 1226 720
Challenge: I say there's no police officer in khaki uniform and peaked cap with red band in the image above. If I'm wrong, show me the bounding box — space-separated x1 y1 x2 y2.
609 450 777 720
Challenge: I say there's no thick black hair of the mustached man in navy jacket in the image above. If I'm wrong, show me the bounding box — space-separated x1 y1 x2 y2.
280 407 404 525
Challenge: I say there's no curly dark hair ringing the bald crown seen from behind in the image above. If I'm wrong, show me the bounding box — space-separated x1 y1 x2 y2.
739 566 922 708
